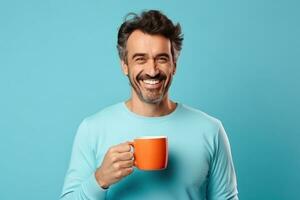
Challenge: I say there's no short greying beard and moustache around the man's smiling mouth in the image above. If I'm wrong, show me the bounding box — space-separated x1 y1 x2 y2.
127 71 172 104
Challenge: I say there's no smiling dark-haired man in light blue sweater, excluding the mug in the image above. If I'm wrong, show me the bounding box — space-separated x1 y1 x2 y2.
61 10 238 200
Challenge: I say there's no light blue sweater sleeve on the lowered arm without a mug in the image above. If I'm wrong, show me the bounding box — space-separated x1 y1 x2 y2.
207 123 238 200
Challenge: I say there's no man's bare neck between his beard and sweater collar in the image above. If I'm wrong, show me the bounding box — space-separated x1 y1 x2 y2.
125 94 177 117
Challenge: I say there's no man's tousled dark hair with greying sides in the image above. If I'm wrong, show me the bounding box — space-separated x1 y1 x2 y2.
117 10 183 63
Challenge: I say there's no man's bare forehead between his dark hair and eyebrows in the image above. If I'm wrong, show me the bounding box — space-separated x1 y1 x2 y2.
126 30 171 56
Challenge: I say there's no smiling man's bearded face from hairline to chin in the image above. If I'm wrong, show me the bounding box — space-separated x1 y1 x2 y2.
122 30 176 104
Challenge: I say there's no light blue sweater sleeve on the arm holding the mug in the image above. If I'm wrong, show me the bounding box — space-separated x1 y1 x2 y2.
60 120 107 200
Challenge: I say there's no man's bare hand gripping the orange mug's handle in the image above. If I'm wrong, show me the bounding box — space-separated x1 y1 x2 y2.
95 142 134 188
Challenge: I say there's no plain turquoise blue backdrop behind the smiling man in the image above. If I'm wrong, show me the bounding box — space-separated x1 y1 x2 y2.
0 0 300 200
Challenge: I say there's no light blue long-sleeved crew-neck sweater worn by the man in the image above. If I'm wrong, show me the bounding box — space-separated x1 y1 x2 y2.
60 102 238 200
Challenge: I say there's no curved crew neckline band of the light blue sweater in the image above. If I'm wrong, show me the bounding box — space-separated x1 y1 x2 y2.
121 101 182 121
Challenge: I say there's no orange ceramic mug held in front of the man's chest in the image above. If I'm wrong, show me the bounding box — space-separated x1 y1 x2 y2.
130 136 168 170
